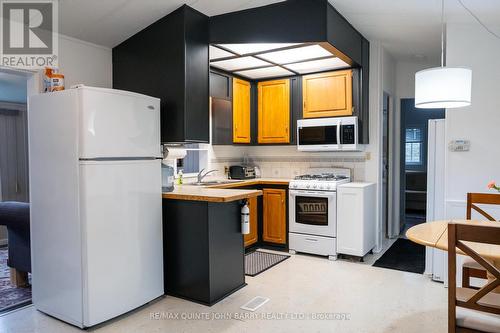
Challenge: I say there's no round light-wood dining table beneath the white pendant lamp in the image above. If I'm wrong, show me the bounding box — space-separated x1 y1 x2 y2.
406 220 500 293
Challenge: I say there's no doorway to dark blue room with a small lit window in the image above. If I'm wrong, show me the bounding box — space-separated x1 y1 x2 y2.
399 98 445 237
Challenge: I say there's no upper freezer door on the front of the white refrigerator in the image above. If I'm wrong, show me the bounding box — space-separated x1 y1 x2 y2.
78 87 160 159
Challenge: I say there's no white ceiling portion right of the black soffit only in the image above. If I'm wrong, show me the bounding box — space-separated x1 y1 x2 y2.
329 0 500 63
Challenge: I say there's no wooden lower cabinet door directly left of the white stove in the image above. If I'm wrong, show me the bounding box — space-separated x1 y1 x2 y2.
262 189 286 244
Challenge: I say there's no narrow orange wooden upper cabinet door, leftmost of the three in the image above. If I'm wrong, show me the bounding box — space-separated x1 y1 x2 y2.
233 78 251 143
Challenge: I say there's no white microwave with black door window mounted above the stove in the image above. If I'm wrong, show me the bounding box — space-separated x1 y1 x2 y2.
297 117 360 151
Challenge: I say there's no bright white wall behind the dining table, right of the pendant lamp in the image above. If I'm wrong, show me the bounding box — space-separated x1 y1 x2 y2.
445 24 500 218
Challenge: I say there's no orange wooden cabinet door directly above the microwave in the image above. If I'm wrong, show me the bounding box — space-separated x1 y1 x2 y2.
302 69 352 118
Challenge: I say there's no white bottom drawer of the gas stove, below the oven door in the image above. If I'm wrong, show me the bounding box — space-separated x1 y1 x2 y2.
288 233 337 256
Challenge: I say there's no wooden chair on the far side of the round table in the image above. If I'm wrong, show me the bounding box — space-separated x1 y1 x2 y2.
462 193 500 289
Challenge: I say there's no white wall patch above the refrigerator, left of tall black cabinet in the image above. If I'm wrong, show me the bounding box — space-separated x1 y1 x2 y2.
59 35 113 89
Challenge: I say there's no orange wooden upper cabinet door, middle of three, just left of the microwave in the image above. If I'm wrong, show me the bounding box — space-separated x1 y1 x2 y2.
258 79 290 143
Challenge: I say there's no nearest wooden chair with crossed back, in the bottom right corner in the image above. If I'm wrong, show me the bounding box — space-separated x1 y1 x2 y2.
448 223 500 333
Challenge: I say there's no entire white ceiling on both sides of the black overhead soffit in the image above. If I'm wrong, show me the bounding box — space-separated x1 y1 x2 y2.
59 0 500 61
